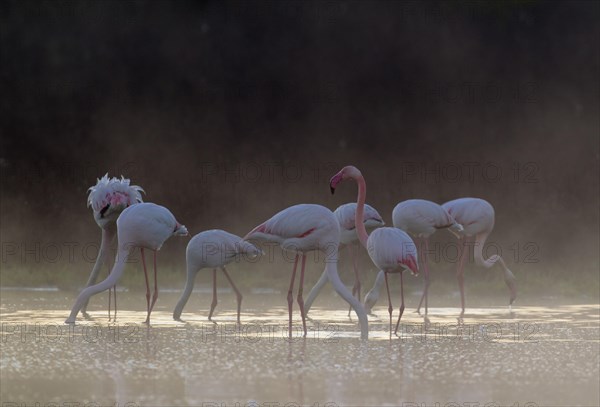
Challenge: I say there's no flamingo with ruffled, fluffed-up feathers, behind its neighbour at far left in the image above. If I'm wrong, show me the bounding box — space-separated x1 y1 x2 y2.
81 173 145 320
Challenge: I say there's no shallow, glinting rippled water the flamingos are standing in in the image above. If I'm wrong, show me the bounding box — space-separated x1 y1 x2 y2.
0 291 600 407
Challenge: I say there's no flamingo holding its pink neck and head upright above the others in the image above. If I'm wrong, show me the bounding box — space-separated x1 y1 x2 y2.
329 165 419 336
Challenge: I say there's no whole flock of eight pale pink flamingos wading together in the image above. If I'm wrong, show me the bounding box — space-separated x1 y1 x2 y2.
65 166 516 339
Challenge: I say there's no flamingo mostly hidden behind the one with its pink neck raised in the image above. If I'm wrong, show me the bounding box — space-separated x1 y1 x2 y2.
304 202 385 315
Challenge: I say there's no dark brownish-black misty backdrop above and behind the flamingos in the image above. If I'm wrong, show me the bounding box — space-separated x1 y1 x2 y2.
0 1 600 295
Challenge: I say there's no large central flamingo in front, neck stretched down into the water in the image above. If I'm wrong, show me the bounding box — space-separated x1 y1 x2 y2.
244 204 369 339
